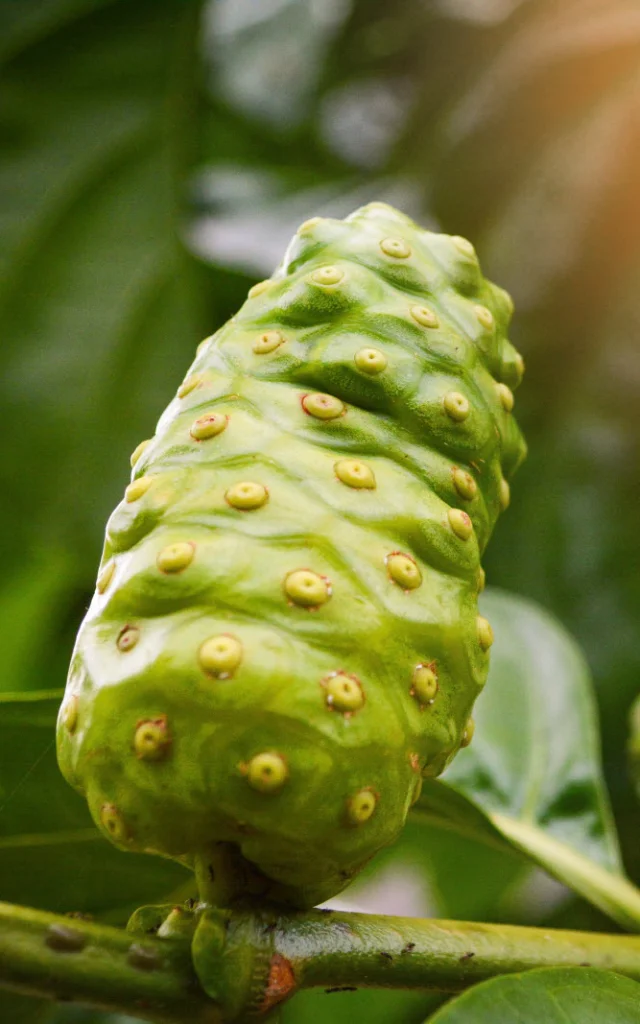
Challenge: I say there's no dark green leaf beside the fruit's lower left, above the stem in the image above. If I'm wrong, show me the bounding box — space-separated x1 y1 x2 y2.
0 692 190 919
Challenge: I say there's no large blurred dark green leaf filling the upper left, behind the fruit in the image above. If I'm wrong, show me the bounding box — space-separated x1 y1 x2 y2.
0 0 205 575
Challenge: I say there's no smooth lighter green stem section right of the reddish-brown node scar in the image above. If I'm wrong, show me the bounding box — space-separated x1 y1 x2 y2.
275 912 640 992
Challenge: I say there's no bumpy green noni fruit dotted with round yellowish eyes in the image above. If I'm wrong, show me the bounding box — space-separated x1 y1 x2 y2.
58 203 525 906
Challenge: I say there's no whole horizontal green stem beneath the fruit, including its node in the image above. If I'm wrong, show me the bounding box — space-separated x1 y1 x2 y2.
0 903 640 1024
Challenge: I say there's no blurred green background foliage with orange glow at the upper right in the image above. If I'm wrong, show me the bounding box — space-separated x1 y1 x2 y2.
0 0 640 1024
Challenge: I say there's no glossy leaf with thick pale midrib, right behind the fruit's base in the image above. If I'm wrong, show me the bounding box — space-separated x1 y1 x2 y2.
415 592 640 929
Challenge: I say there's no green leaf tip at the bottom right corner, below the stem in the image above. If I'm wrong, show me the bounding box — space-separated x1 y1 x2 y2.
429 967 640 1024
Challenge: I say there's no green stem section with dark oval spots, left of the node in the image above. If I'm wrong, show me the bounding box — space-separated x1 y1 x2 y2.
0 903 221 1024
